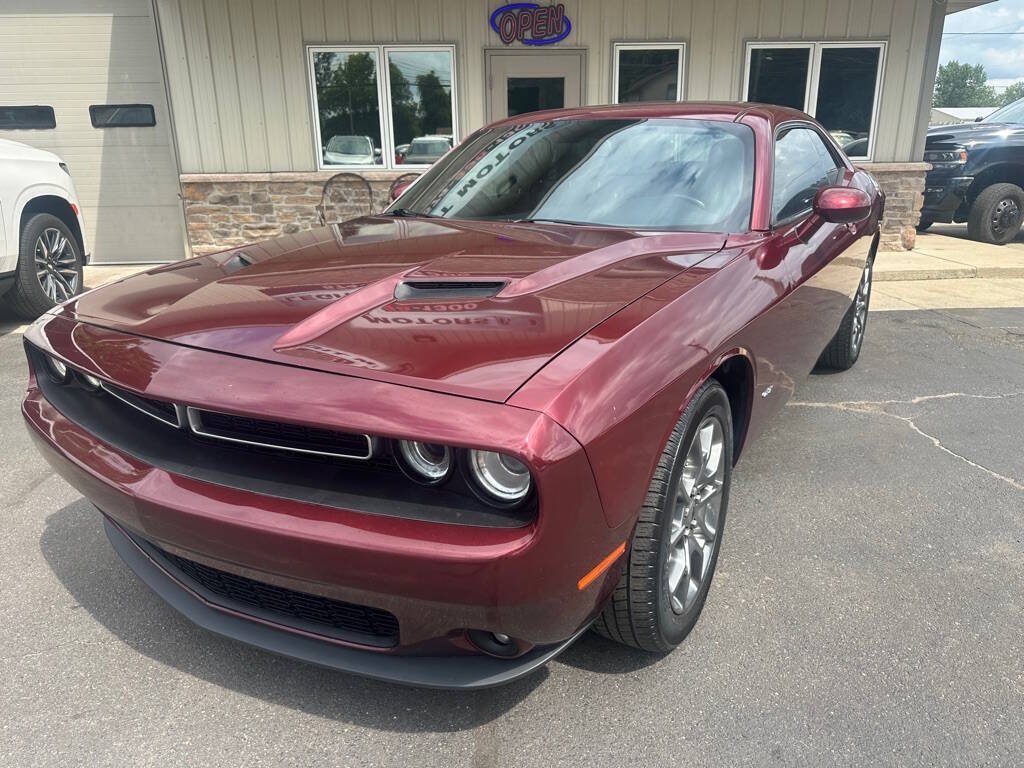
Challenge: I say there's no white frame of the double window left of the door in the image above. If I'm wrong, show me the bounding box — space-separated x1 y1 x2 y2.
305 43 459 173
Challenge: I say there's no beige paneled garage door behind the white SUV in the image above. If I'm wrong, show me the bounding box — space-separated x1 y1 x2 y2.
0 0 184 263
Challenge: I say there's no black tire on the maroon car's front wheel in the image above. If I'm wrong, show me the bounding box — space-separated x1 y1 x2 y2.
593 379 732 653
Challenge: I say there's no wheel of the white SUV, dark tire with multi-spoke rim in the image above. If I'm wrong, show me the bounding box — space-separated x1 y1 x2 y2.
6 213 83 319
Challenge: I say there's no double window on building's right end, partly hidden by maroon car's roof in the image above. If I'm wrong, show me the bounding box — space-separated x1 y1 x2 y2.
743 43 886 160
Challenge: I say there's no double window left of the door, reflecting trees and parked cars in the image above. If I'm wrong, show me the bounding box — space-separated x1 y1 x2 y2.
307 45 458 169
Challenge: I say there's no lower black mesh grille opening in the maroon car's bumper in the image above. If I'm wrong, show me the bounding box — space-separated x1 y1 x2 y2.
154 547 398 646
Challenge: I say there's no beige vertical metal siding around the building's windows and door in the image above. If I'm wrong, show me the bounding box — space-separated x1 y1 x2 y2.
158 0 932 173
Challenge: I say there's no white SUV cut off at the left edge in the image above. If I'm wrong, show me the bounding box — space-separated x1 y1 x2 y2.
0 139 88 319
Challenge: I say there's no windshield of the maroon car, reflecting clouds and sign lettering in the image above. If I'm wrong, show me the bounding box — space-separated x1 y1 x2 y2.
395 119 754 231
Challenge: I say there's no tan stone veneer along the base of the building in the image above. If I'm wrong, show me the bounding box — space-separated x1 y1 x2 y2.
181 163 930 255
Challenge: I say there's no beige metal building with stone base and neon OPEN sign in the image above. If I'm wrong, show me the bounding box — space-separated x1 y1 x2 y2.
0 0 987 262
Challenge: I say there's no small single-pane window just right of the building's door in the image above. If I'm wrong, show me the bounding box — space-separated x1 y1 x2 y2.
611 43 686 104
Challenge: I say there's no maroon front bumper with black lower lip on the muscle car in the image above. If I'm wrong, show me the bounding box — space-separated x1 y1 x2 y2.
23 317 632 687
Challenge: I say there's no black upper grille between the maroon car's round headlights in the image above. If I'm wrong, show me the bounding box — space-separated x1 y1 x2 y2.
26 344 537 527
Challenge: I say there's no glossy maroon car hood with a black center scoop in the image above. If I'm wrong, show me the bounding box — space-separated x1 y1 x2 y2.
66 217 725 401
